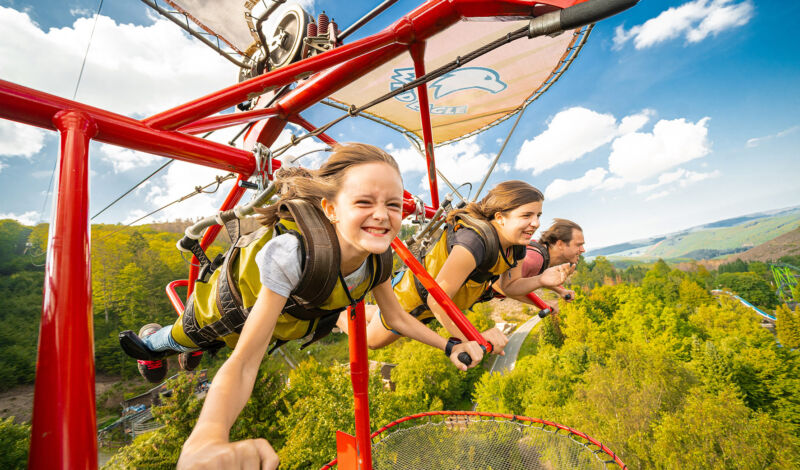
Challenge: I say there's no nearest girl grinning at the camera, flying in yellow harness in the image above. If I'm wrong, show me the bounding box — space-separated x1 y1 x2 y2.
123 144 483 469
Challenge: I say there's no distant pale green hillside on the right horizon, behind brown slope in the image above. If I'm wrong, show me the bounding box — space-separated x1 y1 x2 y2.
586 207 800 260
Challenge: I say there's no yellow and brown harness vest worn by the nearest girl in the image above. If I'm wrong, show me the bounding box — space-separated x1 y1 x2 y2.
172 199 392 349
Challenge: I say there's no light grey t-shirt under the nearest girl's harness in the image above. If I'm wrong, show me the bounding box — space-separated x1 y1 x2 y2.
256 233 369 297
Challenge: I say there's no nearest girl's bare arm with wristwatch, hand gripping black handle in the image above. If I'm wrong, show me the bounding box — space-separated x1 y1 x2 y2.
372 280 483 370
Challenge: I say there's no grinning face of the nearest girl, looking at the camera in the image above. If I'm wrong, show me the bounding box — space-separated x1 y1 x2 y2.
322 162 403 258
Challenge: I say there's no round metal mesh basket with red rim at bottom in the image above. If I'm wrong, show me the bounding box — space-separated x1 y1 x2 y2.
323 411 627 470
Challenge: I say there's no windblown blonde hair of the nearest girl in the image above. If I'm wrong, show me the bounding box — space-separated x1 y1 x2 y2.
256 143 400 226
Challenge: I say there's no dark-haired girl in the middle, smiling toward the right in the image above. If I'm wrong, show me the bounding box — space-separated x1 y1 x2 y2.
348 181 571 354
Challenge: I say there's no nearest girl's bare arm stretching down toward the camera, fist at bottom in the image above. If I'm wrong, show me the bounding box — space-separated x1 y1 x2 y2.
178 287 286 469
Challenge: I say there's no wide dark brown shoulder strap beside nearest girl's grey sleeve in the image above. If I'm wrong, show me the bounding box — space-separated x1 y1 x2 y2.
281 199 341 305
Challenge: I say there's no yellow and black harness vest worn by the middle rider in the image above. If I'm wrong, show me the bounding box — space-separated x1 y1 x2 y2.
394 214 525 320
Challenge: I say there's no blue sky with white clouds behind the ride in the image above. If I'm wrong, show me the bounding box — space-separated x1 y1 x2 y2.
0 0 800 248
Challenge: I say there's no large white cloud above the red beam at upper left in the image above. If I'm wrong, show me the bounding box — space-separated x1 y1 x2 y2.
0 7 236 117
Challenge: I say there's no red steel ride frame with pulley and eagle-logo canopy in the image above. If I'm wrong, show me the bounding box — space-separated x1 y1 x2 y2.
0 0 638 469
